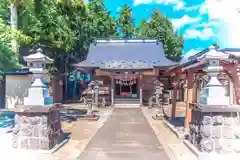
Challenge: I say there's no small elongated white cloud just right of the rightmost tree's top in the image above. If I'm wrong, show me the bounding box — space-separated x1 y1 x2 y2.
172 15 200 30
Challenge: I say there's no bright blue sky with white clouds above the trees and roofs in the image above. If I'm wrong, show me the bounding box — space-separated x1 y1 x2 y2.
105 0 240 55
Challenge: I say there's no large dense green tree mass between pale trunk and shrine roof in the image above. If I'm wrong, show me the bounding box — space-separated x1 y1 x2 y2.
16 0 117 72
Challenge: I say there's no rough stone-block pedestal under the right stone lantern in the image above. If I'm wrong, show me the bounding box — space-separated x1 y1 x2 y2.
189 110 240 153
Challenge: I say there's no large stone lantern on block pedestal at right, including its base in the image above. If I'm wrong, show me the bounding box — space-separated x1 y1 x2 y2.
189 48 240 160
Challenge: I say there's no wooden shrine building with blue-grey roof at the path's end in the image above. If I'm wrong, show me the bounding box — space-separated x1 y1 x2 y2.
73 39 177 106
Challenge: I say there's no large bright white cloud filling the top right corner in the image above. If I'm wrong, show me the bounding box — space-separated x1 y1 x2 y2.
200 0 240 47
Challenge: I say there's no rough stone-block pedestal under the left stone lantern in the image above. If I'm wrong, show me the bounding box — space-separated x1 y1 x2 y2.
12 110 63 150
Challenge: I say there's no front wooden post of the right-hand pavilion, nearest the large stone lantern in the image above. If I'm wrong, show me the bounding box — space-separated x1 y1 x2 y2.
185 70 193 130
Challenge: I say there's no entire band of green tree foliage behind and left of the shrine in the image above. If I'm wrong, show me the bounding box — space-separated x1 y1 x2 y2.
0 0 183 72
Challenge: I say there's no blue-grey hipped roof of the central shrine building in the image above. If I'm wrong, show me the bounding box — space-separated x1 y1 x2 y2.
74 39 177 69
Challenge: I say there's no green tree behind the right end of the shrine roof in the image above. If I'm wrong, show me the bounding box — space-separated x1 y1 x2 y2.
138 9 183 61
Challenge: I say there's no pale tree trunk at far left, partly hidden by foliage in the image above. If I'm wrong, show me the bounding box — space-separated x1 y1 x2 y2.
10 4 18 54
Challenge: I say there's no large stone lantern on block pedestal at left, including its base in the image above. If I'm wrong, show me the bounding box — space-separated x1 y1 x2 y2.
12 49 63 150
